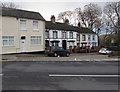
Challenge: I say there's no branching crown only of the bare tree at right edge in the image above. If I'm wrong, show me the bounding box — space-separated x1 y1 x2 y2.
104 1 120 33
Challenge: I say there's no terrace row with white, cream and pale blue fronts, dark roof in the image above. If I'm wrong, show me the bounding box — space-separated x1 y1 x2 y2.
45 16 98 49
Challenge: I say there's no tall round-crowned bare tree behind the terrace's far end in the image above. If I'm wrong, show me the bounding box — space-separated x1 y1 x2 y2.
82 3 102 29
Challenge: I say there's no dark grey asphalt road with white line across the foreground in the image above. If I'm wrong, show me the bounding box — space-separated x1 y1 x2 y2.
2 61 119 90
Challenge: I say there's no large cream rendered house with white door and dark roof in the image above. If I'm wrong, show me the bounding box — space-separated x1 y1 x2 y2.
0 8 45 54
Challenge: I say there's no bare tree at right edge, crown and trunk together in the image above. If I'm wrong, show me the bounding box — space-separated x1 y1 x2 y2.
104 1 120 45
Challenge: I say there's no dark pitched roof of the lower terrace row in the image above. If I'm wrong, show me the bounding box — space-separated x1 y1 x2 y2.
45 21 96 34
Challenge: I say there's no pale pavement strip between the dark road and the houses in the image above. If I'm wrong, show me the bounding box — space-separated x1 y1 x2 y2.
0 53 119 61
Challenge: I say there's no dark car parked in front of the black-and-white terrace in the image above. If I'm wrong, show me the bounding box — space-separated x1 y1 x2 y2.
46 46 70 57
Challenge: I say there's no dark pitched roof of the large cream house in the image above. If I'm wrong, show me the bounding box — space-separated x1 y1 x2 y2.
0 7 45 21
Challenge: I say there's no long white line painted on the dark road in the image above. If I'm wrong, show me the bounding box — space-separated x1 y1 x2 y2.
49 74 120 77
